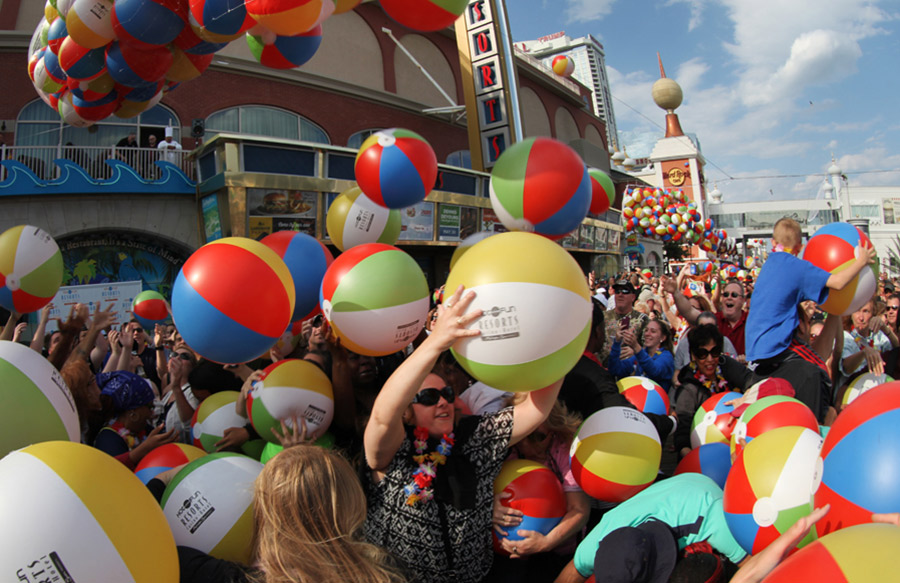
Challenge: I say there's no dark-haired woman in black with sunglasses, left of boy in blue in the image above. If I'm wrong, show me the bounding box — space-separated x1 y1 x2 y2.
674 324 760 457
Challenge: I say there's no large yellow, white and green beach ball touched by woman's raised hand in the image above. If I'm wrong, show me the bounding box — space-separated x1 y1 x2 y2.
445 233 593 391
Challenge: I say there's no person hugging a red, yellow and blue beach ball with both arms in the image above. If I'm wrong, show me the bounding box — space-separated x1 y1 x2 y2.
490 402 591 583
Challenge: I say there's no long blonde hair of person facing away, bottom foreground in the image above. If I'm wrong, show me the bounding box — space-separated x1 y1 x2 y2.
252 446 405 583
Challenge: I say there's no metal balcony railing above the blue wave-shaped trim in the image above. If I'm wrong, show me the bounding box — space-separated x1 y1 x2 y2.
0 145 195 180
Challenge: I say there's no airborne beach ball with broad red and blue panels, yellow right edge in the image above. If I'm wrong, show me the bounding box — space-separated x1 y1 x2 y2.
172 237 296 364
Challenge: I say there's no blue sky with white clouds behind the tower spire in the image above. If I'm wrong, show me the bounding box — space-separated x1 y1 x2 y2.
506 0 900 202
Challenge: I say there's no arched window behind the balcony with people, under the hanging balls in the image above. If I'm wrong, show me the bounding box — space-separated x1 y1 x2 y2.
15 99 181 148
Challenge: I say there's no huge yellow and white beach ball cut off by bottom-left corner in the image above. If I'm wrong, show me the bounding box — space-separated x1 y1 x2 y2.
0 441 179 583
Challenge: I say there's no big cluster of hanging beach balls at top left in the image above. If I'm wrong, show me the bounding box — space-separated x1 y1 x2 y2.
28 0 370 127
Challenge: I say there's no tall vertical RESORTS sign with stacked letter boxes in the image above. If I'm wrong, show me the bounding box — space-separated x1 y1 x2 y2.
456 0 516 170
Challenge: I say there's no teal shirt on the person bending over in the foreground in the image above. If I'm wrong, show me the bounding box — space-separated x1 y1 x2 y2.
574 474 747 577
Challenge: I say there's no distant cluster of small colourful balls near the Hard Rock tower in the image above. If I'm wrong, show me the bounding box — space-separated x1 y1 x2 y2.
622 188 733 252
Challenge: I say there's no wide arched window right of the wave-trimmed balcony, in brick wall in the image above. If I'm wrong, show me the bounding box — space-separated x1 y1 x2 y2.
206 105 331 144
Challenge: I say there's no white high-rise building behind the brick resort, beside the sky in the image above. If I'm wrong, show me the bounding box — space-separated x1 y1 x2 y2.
515 32 621 151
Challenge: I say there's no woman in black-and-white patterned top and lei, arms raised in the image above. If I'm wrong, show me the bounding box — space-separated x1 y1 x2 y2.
364 286 561 583
